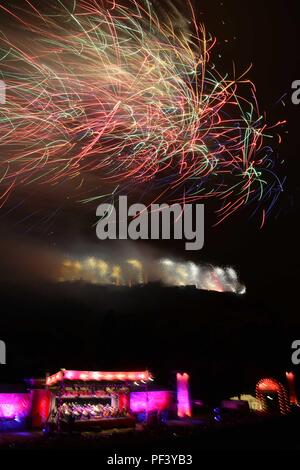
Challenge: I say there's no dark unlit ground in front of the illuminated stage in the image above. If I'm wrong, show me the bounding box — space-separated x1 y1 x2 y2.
0 416 300 456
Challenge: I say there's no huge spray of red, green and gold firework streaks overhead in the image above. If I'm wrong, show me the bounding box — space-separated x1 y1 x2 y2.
0 0 282 221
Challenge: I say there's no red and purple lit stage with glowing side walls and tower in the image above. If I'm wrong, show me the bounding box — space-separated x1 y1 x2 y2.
0 369 191 431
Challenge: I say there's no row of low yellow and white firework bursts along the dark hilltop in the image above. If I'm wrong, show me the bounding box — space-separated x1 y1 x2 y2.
58 253 246 294
